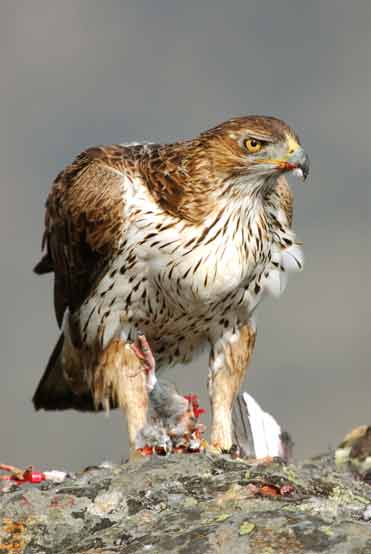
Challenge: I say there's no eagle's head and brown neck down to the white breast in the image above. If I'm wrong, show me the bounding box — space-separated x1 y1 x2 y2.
145 115 309 223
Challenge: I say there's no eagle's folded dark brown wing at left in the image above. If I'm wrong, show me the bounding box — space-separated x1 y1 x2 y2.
35 146 124 325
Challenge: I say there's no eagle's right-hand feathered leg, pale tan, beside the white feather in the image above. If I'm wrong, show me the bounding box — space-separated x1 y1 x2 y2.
208 322 256 450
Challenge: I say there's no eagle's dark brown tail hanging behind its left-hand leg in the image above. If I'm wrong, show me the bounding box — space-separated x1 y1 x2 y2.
32 333 96 412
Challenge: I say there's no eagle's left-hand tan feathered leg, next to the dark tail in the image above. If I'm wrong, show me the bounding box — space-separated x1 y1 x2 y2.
93 332 148 449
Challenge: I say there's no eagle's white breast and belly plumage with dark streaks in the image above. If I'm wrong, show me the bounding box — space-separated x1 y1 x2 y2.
79 175 303 366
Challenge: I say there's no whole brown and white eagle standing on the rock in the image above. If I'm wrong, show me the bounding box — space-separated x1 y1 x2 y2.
33 116 309 450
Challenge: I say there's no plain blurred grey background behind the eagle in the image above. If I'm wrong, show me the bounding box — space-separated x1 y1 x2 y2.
0 0 371 469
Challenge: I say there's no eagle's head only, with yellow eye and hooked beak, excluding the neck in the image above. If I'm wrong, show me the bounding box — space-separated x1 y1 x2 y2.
200 115 309 183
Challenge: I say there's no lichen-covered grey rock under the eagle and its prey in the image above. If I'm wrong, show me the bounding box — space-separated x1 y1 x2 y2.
0 454 371 554
